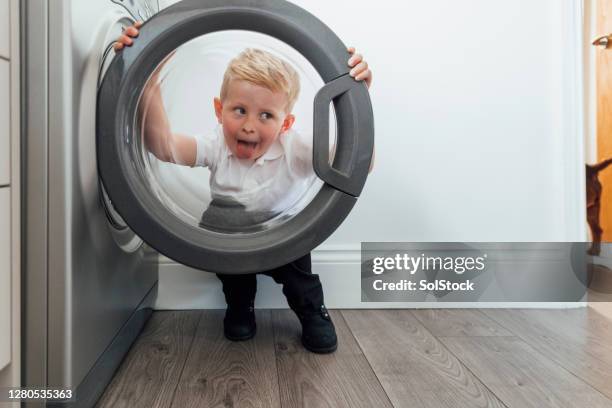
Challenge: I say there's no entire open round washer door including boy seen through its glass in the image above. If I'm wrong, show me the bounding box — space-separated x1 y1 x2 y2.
97 0 374 273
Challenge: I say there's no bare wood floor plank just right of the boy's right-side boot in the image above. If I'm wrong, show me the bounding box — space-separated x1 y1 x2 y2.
342 310 504 408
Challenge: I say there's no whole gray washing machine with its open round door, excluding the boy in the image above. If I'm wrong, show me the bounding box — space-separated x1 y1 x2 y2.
22 0 374 407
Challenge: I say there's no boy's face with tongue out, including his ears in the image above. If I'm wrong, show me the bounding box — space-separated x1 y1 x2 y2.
214 80 295 160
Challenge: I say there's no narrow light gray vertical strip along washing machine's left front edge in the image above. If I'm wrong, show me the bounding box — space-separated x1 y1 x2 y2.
47 1 71 387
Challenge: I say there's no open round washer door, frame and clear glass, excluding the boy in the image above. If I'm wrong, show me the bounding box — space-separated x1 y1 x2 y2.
97 0 374 274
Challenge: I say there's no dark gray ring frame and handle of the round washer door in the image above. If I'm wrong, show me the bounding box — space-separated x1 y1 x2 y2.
96 0 374 274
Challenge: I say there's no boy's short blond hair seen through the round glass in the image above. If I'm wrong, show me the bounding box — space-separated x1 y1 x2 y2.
221 48 300 113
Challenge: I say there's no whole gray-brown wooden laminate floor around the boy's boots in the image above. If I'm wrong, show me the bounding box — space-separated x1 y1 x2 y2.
98 308 612 408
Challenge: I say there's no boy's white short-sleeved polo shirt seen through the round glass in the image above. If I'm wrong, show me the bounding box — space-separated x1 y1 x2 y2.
196 126 316 212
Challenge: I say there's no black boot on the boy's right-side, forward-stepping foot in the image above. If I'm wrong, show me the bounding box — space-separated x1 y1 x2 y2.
293 305 338 354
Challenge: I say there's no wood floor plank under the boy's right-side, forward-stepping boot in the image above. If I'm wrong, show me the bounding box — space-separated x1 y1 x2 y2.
272 310 392 408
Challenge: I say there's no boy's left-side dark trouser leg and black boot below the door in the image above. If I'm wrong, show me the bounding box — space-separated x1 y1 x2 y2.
217 275 257 341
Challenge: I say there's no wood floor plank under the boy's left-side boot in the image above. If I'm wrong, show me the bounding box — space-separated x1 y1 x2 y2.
172 310 280 408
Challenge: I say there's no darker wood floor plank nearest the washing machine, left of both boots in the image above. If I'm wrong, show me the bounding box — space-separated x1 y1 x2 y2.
97 311 200 408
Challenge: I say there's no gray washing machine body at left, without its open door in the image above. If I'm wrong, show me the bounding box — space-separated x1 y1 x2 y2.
21 0 158 407
